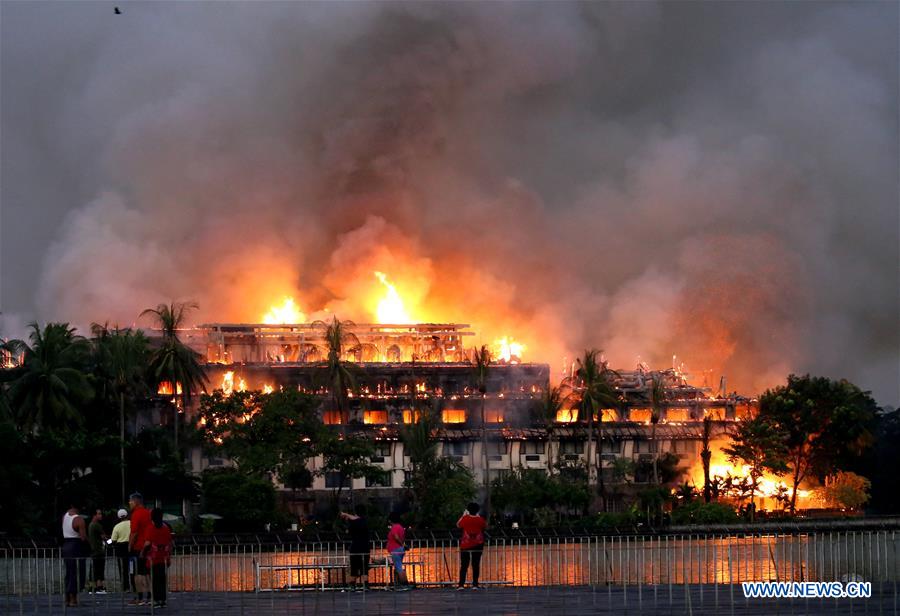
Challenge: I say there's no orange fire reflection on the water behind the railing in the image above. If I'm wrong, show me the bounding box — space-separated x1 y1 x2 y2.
163 532 900 591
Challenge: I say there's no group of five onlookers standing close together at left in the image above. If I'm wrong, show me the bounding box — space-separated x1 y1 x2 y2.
62 492 172 608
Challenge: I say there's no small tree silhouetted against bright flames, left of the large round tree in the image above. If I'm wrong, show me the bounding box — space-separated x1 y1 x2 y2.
722 417 787 510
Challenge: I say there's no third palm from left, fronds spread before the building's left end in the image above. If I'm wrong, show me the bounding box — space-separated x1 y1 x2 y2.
141 302 208 452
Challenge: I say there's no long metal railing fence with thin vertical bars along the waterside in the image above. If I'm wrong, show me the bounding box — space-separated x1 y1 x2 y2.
0 530 900 611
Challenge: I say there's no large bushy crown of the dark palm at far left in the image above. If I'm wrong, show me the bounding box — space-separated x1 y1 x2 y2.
7 323 94 432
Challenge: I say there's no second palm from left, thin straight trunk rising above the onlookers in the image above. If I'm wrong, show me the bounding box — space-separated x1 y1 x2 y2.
91 323 149 503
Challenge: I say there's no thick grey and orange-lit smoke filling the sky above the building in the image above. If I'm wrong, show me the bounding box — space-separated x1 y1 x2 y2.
2 2 900 403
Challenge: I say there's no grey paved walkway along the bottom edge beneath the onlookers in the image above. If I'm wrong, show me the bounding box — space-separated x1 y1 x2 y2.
0 586 898 616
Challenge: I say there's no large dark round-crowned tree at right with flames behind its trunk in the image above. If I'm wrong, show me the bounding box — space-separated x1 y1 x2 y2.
759 374 878 513
